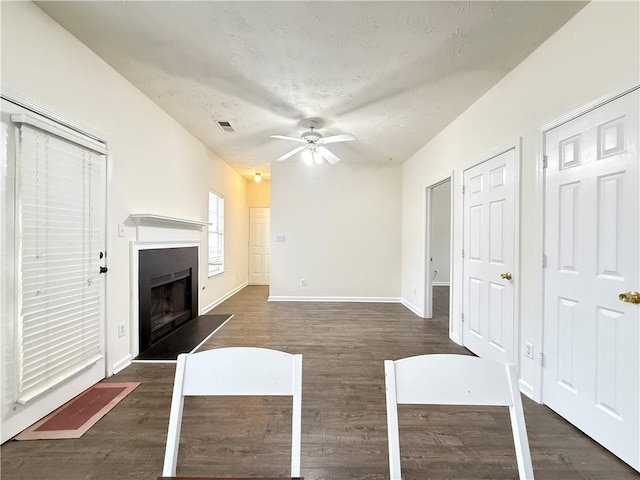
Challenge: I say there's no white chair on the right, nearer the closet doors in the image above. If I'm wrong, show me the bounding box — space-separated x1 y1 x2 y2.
384 355 533 480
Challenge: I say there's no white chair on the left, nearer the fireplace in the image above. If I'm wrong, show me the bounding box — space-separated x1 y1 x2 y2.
162 347 302 477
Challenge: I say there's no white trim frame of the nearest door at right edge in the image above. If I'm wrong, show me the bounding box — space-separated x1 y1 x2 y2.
529 82 640 404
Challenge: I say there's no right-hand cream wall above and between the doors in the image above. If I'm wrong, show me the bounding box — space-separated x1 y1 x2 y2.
402 2 640 394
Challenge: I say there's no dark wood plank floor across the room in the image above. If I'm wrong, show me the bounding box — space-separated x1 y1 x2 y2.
1 287 638 480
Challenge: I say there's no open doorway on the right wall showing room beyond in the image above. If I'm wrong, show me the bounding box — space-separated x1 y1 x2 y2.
424 177 452 318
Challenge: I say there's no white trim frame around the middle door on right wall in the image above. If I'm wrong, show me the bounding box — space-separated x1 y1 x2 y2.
460 136 522 370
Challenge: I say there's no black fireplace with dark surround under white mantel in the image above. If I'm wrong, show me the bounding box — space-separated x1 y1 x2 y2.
138 247 198 353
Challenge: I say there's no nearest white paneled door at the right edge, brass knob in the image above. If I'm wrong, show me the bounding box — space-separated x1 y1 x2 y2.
543 90 640 469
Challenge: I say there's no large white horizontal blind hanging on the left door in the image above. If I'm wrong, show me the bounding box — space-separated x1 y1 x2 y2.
14 119 105 403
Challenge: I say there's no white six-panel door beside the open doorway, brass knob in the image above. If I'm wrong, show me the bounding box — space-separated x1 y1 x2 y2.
462 149 517 363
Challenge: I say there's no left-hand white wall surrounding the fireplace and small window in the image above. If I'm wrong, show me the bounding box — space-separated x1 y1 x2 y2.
1 2 248 372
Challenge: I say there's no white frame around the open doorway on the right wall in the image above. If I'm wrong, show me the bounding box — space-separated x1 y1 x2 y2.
422 171 454 319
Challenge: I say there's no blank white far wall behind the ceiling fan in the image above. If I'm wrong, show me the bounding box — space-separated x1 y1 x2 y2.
270 160 402 301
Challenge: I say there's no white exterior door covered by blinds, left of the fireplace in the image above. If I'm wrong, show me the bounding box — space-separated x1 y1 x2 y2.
0 100 106 442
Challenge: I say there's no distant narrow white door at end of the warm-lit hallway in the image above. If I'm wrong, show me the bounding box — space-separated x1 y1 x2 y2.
249 207 271 285
